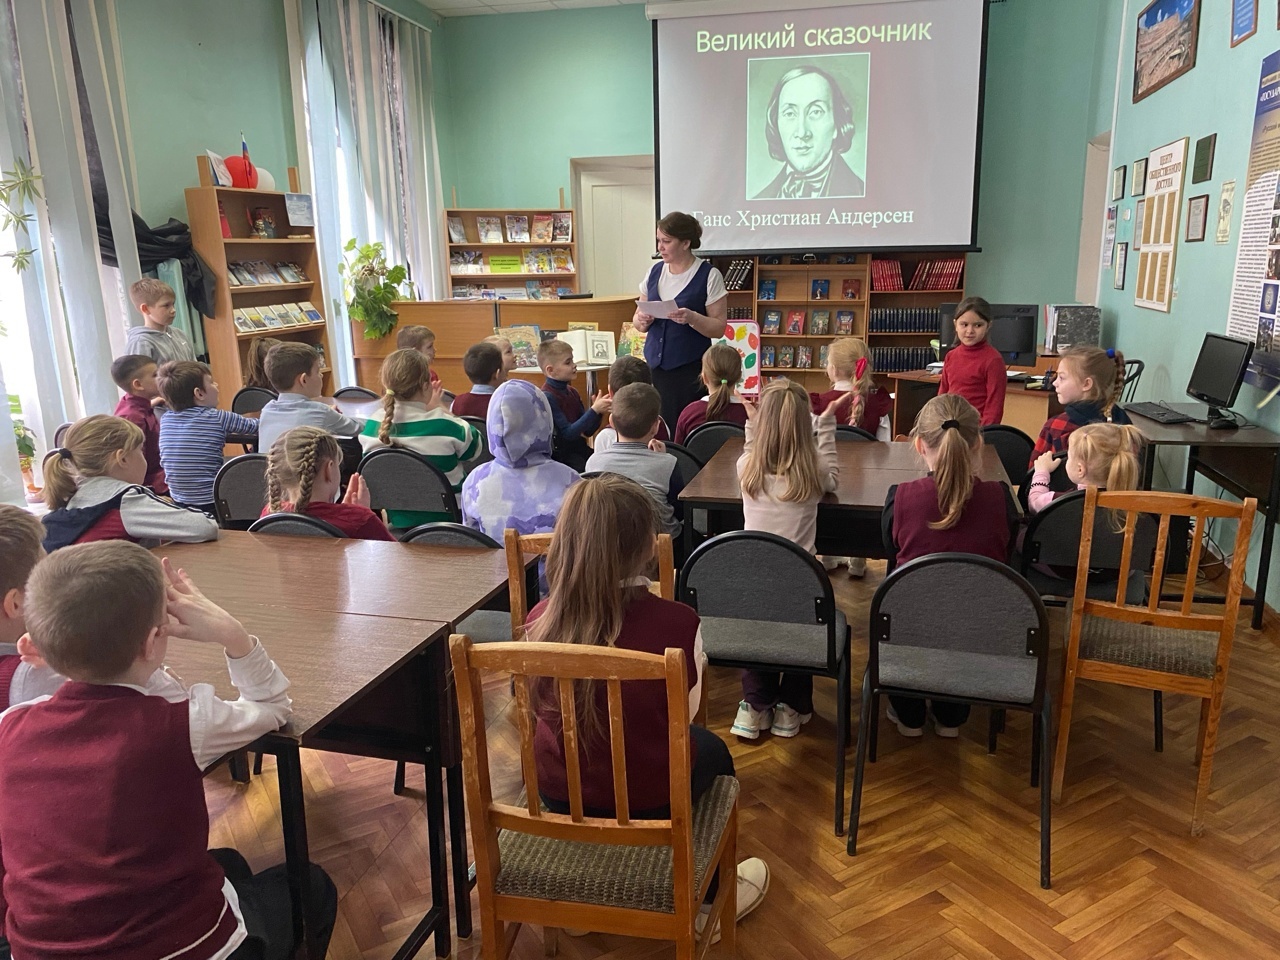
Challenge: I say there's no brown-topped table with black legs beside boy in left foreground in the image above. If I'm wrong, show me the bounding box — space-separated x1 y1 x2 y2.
155 531 517 960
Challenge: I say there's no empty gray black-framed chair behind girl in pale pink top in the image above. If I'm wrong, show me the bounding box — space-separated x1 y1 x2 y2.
676 530 851 836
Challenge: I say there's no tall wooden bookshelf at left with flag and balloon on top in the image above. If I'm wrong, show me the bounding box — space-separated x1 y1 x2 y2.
186 156 334 399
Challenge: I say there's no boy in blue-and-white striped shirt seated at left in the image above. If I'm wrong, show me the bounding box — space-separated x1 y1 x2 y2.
156 360 257 516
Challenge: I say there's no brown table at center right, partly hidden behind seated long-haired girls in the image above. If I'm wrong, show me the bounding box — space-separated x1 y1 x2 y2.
680 436 1009 557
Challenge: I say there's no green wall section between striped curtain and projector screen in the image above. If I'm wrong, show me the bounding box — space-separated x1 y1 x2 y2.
433 4 653 207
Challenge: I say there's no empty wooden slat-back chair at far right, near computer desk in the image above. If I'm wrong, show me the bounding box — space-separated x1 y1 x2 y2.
1053 486 1257 836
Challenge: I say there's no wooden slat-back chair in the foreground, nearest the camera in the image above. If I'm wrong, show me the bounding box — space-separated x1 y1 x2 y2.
449 635 739 960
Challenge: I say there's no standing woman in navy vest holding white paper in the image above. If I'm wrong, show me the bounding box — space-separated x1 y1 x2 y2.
632 212 728 435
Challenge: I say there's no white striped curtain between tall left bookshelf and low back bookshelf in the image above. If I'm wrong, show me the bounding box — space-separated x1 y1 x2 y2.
287 0 443 383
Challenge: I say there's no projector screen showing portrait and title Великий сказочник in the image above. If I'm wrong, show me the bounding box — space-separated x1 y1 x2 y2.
654 0 986 253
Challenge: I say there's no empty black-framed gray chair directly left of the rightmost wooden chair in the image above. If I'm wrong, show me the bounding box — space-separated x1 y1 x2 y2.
847 553 1052 890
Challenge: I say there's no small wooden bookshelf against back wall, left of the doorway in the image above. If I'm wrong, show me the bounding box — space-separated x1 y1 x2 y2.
444 207 580 300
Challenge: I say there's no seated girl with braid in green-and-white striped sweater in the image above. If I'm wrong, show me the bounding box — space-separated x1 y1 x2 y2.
360 349 484 527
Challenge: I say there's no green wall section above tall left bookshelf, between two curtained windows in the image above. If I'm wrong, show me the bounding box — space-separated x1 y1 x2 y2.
115 0 297 225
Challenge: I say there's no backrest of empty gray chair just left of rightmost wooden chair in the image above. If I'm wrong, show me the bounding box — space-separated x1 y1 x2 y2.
868 553 1050 707
